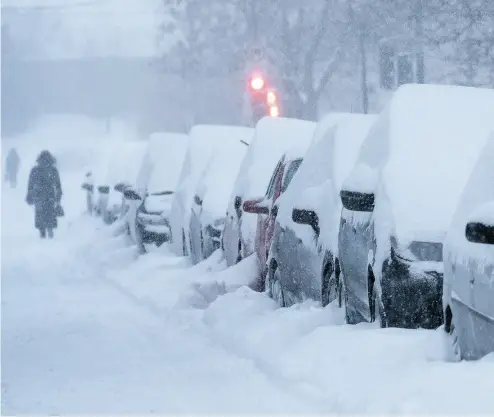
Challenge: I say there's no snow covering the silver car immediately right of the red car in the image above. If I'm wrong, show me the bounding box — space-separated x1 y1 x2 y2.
277 114 377 249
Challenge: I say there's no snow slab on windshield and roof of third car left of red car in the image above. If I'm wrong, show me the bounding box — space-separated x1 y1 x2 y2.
137 132 189 193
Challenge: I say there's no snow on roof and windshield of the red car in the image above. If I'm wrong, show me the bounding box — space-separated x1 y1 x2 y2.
229 117 316 198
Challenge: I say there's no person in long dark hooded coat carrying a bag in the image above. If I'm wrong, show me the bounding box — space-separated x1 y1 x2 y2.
26 151 63 239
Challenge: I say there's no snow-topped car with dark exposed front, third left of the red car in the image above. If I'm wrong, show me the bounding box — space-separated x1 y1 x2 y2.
124 132 189 252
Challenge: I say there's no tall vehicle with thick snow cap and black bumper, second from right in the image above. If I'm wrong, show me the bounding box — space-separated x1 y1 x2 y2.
338 85 494 328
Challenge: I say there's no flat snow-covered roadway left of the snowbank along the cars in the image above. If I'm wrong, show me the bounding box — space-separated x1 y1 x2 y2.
2 188 315 415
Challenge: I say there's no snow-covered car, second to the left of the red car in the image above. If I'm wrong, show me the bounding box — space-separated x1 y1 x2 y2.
170 125 253 255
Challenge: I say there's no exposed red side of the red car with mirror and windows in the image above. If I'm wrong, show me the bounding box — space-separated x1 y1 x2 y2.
243 154 303 292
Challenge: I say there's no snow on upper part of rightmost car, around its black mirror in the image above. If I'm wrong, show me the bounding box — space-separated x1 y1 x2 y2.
443 133 494 262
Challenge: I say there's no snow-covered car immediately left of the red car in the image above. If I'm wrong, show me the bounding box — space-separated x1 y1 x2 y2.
189 127 254 263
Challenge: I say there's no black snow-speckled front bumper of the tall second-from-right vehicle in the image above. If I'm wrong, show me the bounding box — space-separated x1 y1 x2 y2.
381 260 443 329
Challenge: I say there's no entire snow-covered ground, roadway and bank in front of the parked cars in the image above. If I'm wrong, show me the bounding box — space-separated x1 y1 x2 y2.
1 130 494 415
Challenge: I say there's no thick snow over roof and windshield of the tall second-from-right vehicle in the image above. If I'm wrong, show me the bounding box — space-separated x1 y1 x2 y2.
345 85 494 238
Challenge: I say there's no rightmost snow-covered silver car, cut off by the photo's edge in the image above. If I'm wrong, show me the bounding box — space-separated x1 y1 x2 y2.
443 134 494 360
